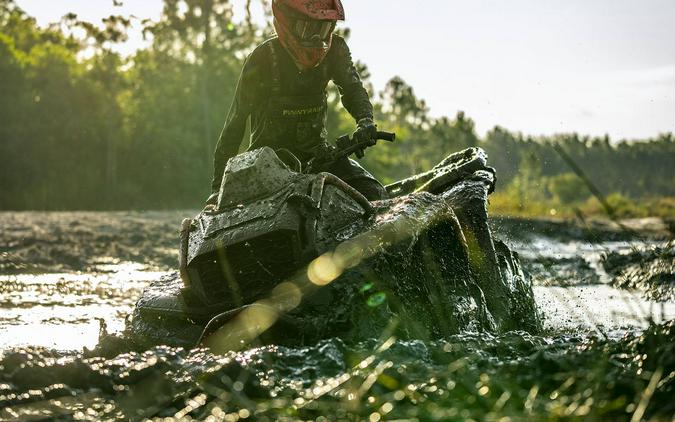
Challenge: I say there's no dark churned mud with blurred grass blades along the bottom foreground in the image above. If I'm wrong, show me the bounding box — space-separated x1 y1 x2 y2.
0 322 675 421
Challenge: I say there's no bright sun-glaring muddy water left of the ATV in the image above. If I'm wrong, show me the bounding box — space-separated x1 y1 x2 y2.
0 263 166 351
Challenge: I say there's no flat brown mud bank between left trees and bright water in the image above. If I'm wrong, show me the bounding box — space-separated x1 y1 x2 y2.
0 211 195 274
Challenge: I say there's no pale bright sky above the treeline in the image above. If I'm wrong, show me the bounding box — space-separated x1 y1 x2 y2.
16 0 675 140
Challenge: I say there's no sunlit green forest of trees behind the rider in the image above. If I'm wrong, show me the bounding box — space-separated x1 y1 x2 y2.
0 0 675 216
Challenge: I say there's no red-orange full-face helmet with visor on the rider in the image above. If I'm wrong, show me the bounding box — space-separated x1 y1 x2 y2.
272 0 345 70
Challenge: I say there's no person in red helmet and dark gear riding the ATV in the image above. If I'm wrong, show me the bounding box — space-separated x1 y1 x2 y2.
208 0 387 204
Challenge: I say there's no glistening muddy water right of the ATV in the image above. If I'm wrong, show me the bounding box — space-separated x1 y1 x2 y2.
511 235 675 336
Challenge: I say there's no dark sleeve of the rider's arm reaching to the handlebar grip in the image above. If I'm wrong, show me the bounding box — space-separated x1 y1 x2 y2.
331 35 373 121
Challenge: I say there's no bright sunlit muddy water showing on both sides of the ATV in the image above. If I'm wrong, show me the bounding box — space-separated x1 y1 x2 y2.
0 263 675 351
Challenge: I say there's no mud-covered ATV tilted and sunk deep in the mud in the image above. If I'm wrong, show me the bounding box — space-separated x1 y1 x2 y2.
130 132 541 350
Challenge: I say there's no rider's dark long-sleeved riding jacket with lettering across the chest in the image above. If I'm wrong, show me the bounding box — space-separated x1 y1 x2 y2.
212 35 373 192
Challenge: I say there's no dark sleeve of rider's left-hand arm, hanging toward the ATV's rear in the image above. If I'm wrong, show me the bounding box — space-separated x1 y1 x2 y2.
211 57 256 193
